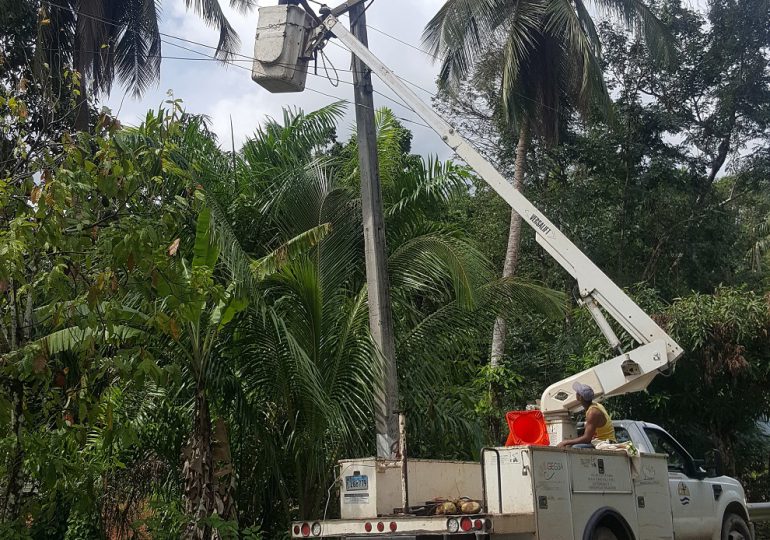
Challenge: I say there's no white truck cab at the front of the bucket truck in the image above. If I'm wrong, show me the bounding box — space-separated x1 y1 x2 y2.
584 420 754 540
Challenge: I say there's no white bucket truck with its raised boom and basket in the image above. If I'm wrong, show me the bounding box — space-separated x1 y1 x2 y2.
252 0 754 540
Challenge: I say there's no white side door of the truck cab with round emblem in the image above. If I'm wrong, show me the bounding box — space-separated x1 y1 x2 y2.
644 428 717 540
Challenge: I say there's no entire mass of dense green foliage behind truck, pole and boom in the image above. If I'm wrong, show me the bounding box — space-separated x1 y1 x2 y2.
0 0 770 539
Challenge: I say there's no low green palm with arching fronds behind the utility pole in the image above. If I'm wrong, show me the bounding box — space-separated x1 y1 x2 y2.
225 104 562 528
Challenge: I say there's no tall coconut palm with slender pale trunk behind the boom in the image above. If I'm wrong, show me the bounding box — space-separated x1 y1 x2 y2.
423 0 670 372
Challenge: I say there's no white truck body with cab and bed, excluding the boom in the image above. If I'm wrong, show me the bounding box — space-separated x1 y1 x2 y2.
292 421 753 540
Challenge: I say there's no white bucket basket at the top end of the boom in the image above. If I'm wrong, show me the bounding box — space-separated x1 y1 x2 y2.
251 5 313 93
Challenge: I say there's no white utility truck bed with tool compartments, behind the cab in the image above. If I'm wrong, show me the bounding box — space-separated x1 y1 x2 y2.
292 446 673 540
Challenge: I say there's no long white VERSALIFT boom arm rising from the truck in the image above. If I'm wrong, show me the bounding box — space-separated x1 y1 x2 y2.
255 0 682 442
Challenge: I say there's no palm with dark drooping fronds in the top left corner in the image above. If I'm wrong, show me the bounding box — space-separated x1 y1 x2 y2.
36 0 249 131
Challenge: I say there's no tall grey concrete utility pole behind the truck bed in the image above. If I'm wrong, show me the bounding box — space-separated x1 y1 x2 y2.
349 2 398 458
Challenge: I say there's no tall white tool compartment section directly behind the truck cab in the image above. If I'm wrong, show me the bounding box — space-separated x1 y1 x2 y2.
482 446 673 540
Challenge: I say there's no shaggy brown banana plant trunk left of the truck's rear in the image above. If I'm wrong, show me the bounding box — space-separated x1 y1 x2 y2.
183 387 216 540
